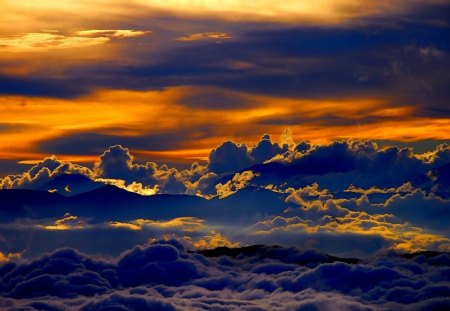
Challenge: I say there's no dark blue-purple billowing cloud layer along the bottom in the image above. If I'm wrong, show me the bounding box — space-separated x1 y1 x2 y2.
0 240 450 310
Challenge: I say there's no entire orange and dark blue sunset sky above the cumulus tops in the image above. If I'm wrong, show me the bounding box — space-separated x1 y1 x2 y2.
0 0 450 174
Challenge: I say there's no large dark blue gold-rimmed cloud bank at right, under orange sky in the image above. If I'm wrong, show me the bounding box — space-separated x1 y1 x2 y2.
250 140 448 191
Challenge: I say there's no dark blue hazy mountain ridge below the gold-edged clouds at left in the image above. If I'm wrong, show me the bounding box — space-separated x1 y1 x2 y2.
0 185 286 223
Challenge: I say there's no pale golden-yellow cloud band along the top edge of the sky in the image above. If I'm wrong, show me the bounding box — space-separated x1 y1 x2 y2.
0 0 443 32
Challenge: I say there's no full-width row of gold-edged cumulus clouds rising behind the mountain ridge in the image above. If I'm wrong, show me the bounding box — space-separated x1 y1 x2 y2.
6 134 450 197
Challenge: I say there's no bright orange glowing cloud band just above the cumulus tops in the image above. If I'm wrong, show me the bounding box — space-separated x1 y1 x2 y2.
0 87 450 161
